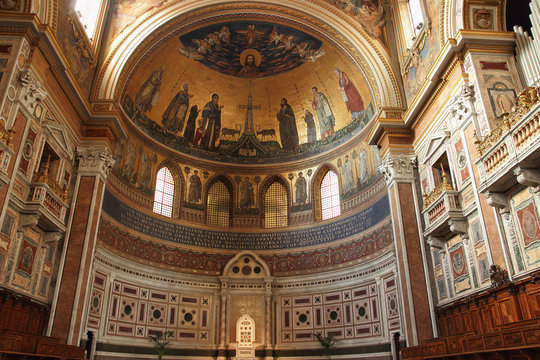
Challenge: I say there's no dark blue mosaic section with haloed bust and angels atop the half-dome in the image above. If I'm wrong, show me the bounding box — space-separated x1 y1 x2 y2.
178 21 324 78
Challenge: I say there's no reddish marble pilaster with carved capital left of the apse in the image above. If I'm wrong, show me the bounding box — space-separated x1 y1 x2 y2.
47 146 114 345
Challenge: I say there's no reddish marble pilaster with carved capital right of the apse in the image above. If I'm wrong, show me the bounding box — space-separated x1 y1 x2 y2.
379 152 436 346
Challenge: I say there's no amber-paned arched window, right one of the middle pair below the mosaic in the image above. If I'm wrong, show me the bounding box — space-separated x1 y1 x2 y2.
264 181 289 228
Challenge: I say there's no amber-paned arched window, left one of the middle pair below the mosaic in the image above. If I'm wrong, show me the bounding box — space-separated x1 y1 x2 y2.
206 181 231 226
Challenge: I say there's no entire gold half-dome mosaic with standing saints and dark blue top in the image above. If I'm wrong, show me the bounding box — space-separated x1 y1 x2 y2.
123 21 375 163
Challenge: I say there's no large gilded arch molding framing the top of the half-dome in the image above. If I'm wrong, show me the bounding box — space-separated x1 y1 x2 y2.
93 0 404 108
